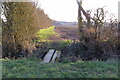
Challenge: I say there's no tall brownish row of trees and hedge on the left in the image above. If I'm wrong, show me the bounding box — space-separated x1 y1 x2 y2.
1 2 52 58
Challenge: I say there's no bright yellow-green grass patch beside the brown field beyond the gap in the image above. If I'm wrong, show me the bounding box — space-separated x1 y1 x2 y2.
36 26 55 41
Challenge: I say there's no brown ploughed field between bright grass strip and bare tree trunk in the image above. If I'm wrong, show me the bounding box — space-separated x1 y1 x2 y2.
50 25 77 40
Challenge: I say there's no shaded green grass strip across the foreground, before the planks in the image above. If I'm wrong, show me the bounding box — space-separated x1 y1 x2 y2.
2 59 118 78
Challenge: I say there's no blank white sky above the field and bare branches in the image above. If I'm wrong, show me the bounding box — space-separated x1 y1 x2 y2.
39 0 120 21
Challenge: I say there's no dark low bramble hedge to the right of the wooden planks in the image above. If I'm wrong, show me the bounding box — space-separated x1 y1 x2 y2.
60 41 115 61
